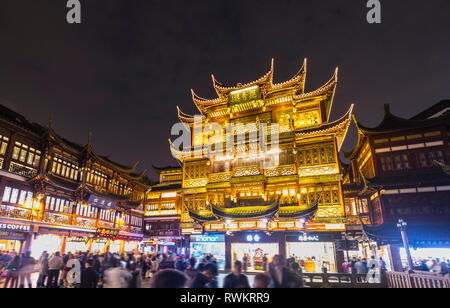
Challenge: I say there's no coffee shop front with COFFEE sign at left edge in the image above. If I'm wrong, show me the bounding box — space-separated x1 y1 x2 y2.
0 223 32 253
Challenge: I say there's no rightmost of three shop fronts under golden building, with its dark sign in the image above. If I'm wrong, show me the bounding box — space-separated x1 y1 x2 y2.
286 233 338 273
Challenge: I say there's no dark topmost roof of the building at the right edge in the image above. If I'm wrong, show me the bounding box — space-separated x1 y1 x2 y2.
354 104 450 135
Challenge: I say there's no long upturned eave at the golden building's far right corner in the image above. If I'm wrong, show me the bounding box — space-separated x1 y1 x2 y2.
295 104 355 150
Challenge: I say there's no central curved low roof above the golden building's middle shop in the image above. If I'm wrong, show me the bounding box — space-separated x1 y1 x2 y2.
211 196 281 220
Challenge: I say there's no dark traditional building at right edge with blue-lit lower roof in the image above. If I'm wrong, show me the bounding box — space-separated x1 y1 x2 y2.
343 100 450 270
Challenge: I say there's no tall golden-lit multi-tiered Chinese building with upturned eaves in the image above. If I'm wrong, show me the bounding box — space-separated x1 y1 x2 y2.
171 60 353 271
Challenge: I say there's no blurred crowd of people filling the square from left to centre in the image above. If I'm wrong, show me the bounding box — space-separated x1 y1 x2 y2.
0 251 303 288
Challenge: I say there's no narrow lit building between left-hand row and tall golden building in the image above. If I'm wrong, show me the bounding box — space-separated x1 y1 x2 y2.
144 166 184 254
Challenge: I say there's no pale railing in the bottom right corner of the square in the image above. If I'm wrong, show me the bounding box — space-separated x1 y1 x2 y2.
386 271 450 289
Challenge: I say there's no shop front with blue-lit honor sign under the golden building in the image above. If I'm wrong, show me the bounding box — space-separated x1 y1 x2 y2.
189 233 225 270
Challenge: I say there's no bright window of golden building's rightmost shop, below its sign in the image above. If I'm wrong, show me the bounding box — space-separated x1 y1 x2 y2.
286 242 337 273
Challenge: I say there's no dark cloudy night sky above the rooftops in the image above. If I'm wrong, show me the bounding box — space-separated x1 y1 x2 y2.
0 0 450 176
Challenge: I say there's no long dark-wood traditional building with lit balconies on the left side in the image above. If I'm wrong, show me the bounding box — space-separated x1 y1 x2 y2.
0 105 148 257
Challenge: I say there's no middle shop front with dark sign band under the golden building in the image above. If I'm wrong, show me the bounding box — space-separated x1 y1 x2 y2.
225 231 286 272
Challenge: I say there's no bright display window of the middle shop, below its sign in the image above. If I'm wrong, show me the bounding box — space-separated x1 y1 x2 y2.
231 243 279 272
